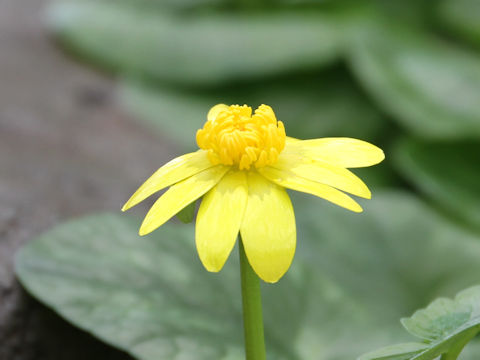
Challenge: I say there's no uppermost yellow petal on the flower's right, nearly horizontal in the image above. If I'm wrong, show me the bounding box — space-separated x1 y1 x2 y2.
284 138 385 168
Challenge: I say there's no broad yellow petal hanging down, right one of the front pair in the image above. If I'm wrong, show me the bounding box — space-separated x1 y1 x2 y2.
240 172 296 283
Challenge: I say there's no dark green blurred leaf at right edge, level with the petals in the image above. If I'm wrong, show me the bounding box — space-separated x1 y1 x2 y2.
393 140 480 232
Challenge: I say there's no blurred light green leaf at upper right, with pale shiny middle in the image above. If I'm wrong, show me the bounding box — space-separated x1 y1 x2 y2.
349 21 480 139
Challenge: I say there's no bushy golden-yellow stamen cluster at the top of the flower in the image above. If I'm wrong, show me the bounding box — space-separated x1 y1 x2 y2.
197 104 286 170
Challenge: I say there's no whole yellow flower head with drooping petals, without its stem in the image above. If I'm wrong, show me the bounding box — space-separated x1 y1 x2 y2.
122 104 384 282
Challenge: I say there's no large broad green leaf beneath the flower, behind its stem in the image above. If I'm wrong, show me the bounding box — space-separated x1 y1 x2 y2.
16 193 480 360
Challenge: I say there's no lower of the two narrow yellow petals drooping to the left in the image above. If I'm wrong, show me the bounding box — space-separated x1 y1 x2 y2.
139 165 229 235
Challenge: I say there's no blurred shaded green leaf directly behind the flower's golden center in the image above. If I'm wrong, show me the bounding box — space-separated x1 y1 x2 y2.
122 73 386 150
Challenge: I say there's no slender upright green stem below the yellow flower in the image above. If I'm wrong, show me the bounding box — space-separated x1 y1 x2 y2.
239 237 265 360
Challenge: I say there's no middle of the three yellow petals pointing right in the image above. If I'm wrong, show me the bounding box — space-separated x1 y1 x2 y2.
271 152 372 199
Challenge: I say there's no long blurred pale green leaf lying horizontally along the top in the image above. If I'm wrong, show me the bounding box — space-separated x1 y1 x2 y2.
49 1 341 84
